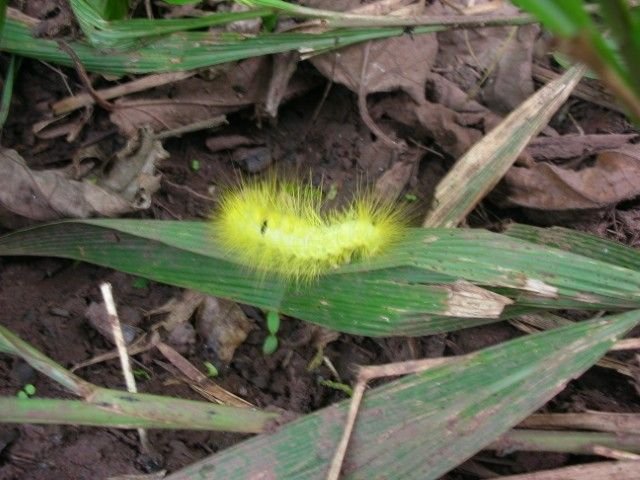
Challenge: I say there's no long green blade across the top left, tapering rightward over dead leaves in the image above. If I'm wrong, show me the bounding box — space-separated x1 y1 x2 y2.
0 14 444 75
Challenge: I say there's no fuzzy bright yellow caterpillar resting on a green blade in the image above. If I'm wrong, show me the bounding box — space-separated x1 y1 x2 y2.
212 178 407 282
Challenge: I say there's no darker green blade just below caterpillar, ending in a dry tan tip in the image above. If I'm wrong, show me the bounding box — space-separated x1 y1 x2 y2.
0 220 500 336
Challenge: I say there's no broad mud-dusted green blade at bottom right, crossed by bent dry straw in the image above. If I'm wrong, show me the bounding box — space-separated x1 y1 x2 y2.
167 311 640 480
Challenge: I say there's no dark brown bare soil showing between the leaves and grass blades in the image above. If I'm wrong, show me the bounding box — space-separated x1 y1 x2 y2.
0 1 640 480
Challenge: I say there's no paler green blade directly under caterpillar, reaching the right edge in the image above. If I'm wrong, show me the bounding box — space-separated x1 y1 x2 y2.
75 219 640 308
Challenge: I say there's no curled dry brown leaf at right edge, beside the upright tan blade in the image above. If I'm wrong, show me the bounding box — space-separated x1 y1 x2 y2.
497 145 640 211
